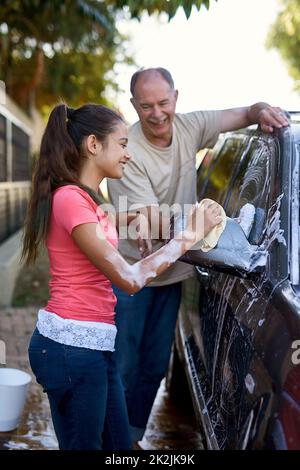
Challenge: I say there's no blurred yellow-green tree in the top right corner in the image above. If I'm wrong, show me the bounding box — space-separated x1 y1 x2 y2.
267 0 300 92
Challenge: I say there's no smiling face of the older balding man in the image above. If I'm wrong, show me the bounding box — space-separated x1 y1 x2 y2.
131 74 178 145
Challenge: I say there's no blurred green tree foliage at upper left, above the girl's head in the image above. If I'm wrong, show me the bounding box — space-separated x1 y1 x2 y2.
0 0 217 115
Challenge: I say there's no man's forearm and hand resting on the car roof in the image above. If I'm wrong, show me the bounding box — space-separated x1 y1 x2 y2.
221 103 289 133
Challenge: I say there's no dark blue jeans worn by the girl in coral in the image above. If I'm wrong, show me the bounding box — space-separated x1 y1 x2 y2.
28 329 131 450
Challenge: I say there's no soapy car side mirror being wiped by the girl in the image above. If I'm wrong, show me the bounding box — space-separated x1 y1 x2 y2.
180 217 267 277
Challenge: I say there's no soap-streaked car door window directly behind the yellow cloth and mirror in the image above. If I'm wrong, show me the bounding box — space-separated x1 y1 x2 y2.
225 137 274 244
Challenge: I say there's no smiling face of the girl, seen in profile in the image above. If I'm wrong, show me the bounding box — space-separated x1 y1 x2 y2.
95 122 130 178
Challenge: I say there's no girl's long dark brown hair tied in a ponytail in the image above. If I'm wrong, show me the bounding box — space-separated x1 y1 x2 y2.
22 104 123 263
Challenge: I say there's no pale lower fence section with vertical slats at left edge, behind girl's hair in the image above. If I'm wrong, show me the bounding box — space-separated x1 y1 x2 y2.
0 181 31 243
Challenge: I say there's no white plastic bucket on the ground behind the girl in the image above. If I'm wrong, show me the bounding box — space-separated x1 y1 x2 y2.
0 367 31 432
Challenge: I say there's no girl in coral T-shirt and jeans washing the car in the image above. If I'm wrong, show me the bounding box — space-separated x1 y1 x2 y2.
23 104 221 450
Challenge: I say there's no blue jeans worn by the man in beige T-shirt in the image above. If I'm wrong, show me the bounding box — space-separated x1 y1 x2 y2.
114 282 181 428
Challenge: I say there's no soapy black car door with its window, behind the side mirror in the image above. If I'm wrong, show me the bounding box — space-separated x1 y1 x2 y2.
211 136 280 447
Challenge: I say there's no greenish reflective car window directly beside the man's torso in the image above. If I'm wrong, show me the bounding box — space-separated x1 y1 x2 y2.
197 135 245 204
